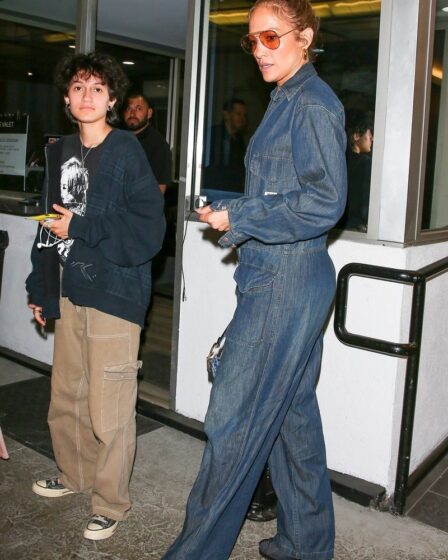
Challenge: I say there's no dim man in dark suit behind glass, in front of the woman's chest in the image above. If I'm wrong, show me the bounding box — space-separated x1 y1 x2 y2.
203 97 247 196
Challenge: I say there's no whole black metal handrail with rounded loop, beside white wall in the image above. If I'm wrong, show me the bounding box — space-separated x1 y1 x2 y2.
334 258 448 515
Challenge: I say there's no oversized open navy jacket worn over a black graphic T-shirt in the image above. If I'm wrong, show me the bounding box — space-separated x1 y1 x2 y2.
26 130 165 326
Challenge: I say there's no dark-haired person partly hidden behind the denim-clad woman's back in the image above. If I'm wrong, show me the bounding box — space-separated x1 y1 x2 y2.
336 110 373 233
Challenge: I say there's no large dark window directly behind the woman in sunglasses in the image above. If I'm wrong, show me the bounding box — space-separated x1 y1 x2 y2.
201 0 381 231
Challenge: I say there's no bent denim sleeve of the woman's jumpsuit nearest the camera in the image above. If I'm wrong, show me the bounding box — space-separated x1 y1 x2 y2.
212 105 347 247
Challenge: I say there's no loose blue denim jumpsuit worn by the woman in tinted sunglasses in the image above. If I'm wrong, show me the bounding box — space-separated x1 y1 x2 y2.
164 63 346 560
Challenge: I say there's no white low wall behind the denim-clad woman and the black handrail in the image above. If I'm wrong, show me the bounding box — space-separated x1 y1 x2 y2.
176 222 448 492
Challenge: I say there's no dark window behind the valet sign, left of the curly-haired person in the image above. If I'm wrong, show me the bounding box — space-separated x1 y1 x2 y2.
0 14 75 192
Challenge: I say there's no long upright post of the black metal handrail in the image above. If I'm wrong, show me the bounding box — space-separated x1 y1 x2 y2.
391 277 426 515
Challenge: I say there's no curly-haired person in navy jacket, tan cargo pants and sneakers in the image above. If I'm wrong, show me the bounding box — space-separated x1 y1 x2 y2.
26 53 165 540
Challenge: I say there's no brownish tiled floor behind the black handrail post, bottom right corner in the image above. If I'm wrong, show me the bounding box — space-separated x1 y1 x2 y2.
406 453 448 533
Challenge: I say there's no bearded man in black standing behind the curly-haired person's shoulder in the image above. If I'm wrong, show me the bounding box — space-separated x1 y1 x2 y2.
123 92 172 194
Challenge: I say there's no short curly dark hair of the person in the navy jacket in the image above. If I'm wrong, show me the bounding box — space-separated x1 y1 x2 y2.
54 51 129 125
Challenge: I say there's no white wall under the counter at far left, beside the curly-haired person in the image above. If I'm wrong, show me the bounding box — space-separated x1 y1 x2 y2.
0 214 53 364
